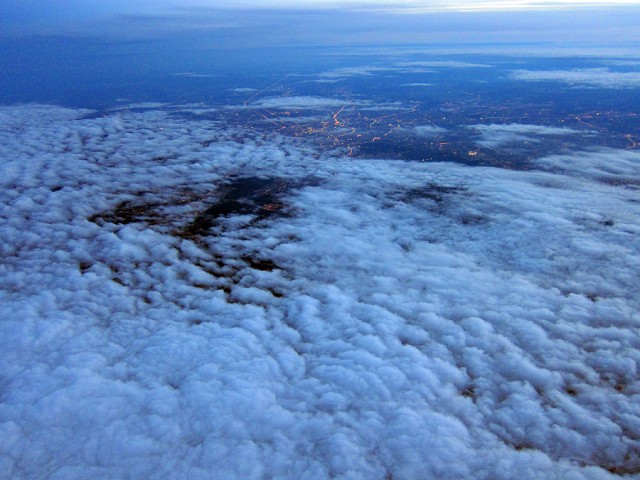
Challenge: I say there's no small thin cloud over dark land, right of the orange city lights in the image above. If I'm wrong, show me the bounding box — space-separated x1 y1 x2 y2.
467 123 582 149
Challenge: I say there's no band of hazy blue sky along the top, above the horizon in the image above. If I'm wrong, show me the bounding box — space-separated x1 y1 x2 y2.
0 0 640 48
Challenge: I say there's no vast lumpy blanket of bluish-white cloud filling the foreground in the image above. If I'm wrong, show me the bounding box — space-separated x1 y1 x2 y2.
0 100 640 479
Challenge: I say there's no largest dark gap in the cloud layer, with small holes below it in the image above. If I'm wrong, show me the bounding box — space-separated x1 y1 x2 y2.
85 175 317 304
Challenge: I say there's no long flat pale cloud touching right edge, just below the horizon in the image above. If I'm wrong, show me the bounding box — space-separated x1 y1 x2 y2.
510 68 640 88
